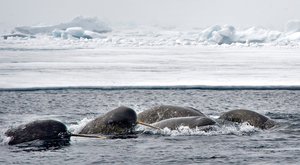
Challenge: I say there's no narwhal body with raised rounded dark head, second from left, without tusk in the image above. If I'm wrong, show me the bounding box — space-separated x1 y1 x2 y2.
80 106 137 135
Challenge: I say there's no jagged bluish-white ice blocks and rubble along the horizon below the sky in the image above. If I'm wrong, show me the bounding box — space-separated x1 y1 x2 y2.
2 17 300 47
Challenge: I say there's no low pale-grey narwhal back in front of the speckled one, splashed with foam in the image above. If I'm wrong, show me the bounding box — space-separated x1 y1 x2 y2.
152 116 216 130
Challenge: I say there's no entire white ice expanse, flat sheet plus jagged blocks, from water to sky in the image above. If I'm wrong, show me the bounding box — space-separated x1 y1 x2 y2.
0 17 300 89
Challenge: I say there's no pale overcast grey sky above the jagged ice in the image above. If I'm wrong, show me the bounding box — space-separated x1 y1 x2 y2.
0 0 300 29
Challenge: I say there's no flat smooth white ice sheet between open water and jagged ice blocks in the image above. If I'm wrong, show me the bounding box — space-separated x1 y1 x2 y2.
0 47 300 88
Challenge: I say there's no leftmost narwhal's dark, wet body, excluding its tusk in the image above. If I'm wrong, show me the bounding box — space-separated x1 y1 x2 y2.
5 120 70 145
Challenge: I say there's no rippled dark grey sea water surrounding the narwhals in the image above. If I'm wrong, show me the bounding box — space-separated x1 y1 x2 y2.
0 89 300 164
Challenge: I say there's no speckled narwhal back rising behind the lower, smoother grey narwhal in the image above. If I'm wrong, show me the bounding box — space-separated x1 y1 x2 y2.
138 105 205 124
